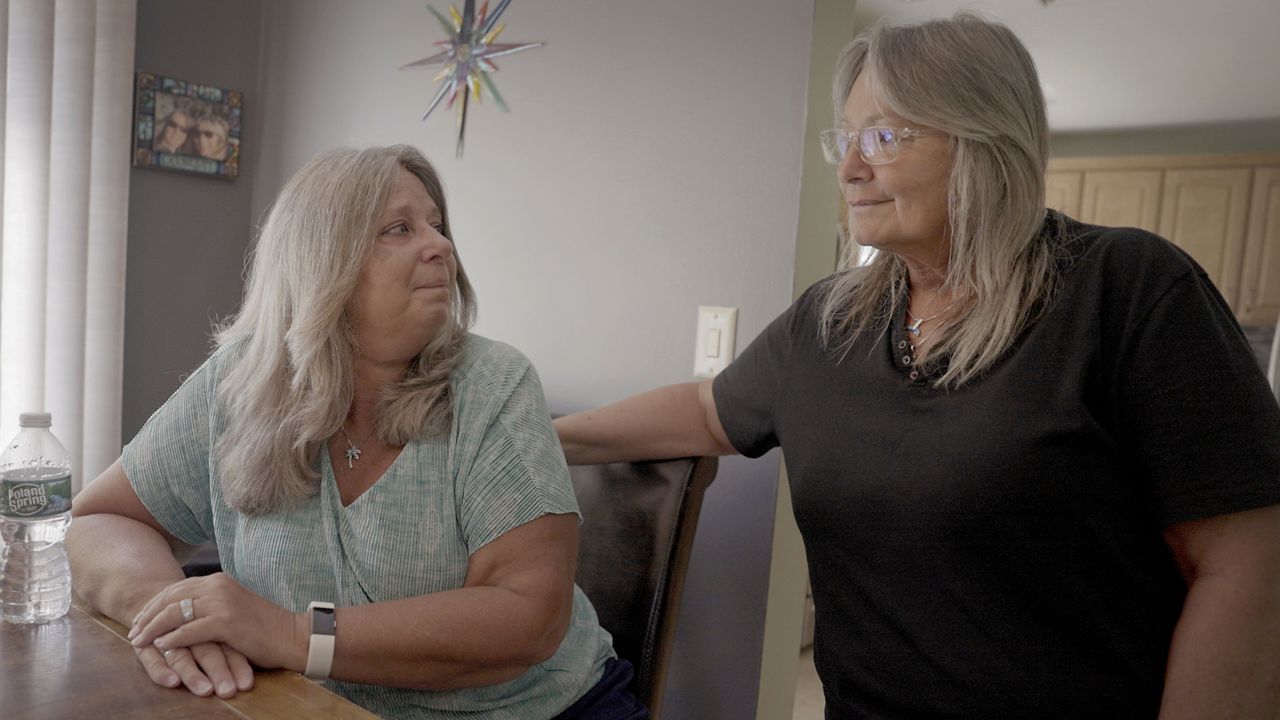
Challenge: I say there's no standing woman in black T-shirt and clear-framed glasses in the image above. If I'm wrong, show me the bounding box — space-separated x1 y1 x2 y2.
557 14 1280 720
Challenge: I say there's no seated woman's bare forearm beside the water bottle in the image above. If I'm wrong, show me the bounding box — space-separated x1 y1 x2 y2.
67 514 183 625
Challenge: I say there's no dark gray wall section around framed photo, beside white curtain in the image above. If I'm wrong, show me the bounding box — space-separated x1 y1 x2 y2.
122 0 261 442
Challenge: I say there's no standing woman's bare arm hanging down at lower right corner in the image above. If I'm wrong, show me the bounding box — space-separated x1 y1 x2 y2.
1160 506 1280 720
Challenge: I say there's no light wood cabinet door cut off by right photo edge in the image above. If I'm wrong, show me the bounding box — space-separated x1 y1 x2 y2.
1236 167 1280 325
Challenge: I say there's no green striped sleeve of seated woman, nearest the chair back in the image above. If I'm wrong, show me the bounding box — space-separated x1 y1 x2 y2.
456 365 577 553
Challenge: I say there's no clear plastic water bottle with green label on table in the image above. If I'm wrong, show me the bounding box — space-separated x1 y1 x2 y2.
0 413 72 623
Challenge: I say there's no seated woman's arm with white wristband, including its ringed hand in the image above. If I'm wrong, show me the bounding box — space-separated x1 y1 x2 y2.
132 515 577 691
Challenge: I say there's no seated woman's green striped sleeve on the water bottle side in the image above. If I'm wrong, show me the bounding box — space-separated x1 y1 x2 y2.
122 354 216 544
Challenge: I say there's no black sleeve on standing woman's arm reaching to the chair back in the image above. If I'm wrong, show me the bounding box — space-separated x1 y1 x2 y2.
712 290 798 457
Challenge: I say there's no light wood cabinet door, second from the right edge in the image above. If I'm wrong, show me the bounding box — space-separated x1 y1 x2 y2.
1160 168 1253 310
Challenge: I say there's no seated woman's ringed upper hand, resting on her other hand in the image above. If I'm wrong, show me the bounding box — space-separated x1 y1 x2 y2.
129 573 307 670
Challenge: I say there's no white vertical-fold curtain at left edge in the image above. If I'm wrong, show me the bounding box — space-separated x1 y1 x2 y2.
0 0 137 489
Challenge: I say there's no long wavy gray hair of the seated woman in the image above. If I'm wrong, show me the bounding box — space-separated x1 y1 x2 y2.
215 145 475 515
